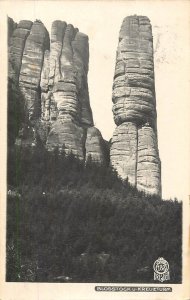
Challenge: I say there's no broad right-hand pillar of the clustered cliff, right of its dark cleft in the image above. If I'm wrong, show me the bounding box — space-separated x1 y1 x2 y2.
41 21 93 159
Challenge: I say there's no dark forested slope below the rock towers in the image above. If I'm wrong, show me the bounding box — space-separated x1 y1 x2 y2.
6 146 182 283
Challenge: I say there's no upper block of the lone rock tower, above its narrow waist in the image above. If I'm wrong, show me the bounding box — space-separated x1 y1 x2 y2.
113 16 156 126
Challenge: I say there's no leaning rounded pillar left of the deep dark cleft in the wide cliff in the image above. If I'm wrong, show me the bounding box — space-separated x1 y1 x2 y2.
19 21 49 119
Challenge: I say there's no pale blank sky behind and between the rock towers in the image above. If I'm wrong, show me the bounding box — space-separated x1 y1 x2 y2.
1 0 190 200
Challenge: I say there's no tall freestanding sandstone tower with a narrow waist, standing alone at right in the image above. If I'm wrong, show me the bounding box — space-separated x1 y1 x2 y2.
110 15 161 195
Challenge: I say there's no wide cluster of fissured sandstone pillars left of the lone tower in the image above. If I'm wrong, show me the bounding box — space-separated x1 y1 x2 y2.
8 18 106 162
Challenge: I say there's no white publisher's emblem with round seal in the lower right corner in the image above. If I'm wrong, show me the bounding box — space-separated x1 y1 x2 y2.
153 257 170 282
